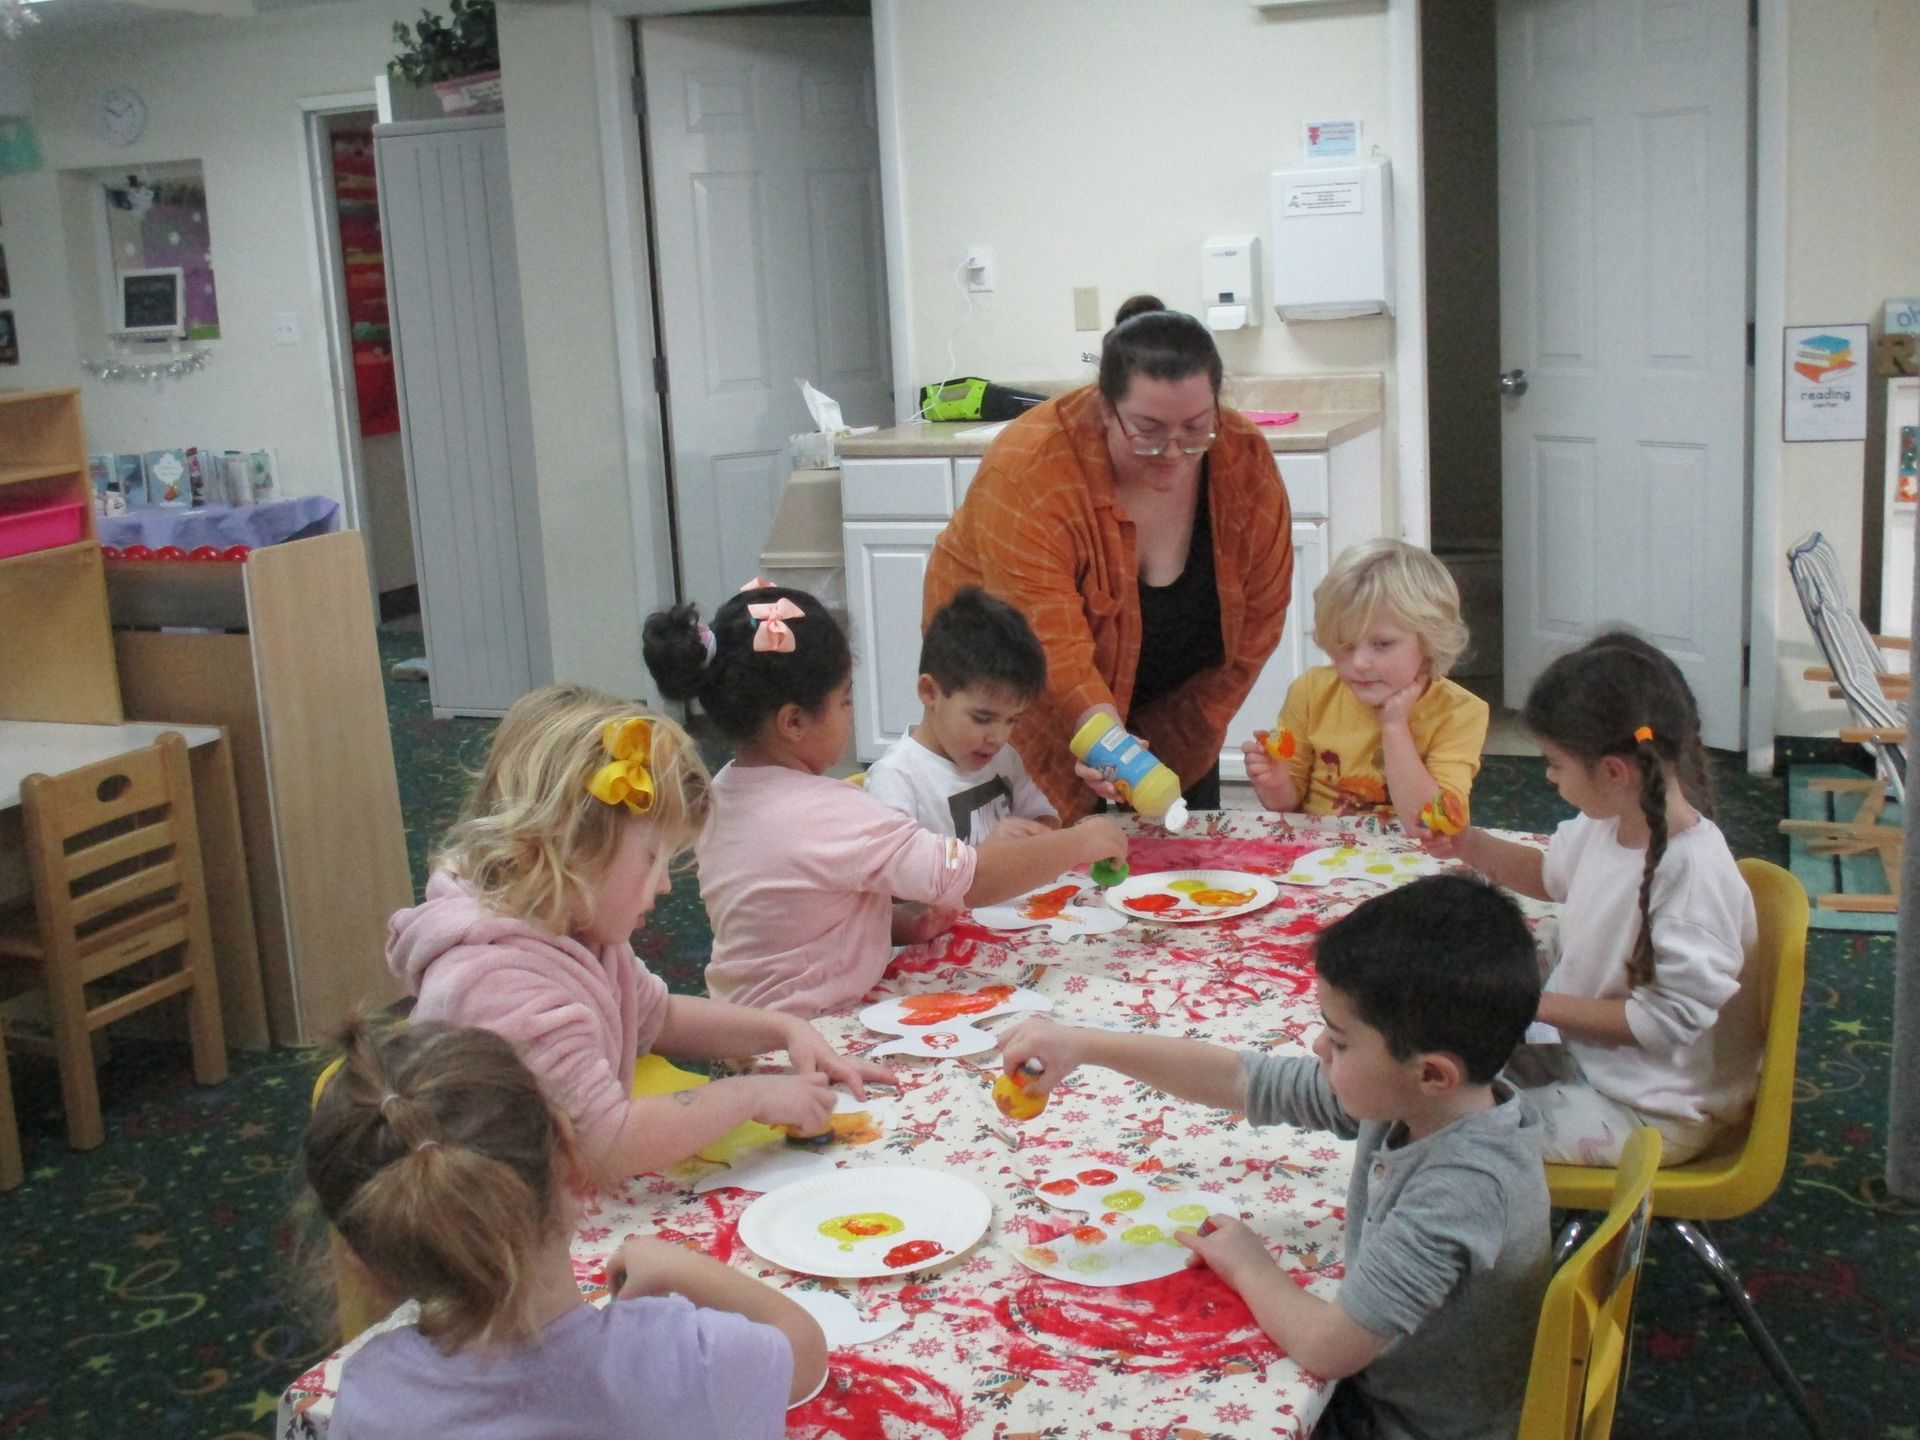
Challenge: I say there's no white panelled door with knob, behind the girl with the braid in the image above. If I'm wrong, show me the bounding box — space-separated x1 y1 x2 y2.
1497 0 1749 749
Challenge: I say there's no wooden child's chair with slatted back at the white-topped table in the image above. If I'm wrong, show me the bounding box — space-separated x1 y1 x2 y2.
0 732 227 1150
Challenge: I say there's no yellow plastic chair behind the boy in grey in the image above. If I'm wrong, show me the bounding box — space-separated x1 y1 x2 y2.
1519 1125 1661 1440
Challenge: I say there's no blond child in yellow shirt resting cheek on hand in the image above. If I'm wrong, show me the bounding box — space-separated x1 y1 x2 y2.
1240 540 1488 829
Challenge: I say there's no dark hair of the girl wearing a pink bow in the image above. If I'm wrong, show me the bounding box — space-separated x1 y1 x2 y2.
639 586 852 743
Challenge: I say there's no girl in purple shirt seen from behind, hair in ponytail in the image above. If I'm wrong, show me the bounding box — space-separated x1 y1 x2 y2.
301 1023 826 1440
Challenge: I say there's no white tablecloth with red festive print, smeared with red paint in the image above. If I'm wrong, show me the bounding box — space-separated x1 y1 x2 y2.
280 812 1551 1440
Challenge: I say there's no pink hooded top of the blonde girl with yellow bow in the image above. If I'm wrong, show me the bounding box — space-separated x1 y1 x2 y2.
386 872 668 1156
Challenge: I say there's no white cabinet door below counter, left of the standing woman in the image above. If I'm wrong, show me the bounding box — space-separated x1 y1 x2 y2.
845 522 947 762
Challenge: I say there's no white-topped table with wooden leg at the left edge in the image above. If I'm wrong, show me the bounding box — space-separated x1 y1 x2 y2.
0 720 267 1050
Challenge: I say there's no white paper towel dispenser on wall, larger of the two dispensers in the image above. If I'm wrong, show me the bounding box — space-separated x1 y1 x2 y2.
1267 159 1394 321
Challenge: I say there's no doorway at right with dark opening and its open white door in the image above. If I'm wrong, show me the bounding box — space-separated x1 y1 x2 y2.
1421 0 1753 749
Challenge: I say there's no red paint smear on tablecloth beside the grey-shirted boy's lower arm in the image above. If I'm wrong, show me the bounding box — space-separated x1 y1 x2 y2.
995 1267 1281 1373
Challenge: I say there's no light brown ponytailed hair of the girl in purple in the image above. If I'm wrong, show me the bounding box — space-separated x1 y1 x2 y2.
301 1021 559 1354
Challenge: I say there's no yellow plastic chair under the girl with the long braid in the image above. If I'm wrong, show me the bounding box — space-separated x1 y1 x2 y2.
1548 860 1824 1440
